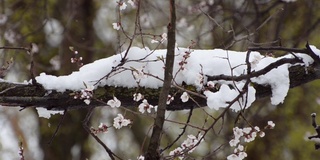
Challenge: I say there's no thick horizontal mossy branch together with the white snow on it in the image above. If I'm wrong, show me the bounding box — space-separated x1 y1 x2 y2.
0 43 320 111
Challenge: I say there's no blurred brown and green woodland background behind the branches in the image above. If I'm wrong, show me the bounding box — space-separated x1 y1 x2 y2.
0 0 320 160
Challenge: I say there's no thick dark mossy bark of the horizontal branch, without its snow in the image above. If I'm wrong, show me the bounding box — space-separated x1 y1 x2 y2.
0 62 320 110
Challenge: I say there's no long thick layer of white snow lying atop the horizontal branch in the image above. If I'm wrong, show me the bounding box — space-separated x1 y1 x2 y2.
36 46 320 111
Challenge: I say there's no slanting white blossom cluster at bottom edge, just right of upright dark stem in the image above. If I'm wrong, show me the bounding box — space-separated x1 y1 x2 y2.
169 133 203 159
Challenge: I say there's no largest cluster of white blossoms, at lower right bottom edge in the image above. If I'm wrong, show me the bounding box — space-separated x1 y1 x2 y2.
227 121 275 160
